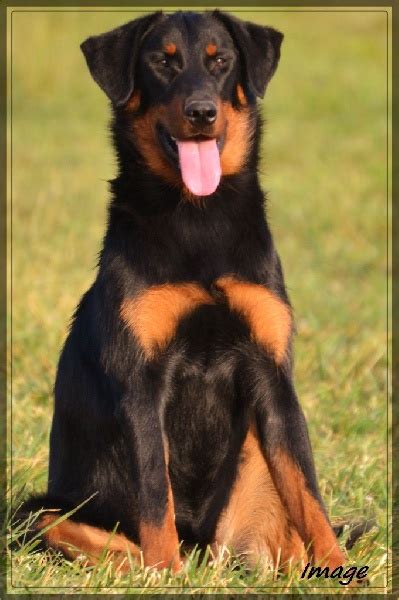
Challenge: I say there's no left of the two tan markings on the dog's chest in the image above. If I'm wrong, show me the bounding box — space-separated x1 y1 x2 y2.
120 283 214 358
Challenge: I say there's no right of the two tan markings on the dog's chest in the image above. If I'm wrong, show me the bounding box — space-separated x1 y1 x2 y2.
216 276 292 363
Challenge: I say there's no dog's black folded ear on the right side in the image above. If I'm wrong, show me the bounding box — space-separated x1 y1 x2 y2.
213 10 284 98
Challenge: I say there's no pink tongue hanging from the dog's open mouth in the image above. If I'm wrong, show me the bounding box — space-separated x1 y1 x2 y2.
177 140 221 196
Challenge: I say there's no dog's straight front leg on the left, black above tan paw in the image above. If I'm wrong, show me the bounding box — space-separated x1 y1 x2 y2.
122 372 180 571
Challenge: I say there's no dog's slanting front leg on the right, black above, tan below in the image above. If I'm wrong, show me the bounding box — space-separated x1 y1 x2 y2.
255 365 345 568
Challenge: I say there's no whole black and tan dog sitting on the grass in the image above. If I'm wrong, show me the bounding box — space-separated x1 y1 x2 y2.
18 11 345 570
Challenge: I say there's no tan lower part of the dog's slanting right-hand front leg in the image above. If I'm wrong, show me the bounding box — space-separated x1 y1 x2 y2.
273 450 346 569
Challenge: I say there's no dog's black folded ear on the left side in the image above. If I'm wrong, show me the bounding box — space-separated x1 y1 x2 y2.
80 11 164 106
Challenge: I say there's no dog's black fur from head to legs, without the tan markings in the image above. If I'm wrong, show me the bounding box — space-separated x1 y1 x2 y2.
14 11 340 568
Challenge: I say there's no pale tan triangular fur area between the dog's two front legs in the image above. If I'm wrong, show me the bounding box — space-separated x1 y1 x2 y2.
215 426 306 567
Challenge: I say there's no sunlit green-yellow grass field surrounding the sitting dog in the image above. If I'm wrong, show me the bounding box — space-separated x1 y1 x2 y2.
8 5 389 594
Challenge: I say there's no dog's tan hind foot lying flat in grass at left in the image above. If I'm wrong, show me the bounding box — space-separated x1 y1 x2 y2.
39 513 140 571
